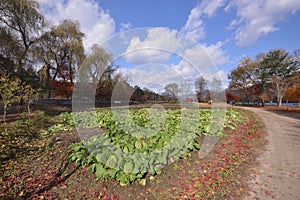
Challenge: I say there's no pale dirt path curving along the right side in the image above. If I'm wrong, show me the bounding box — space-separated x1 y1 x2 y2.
246 108 300 200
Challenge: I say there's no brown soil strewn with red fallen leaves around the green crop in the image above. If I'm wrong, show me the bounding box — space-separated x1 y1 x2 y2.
0 106 265 200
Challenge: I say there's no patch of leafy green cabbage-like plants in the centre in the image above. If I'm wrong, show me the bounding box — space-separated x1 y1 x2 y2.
56 108 240 186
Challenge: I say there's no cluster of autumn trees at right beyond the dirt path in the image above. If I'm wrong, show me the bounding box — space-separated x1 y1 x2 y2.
227 49 300 106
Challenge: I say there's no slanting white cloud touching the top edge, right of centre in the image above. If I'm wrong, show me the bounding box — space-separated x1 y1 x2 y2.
181 0 225 40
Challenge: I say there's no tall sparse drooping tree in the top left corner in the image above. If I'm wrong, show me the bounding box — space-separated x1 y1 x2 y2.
0 0 44 79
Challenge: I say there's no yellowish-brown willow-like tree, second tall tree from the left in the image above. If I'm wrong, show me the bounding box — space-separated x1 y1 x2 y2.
35 20 84 97
